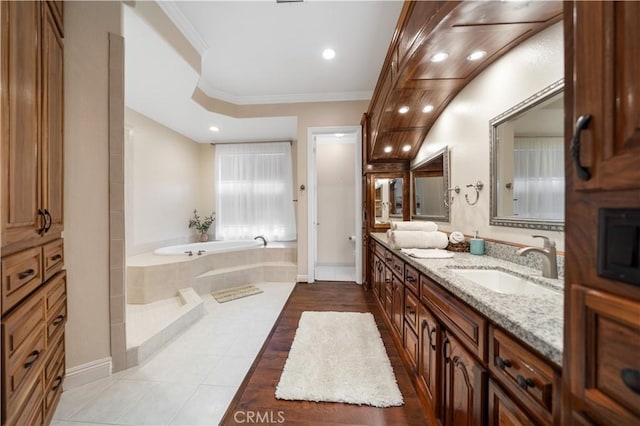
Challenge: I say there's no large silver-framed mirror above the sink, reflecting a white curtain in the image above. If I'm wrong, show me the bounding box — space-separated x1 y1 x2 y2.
489 80 565 231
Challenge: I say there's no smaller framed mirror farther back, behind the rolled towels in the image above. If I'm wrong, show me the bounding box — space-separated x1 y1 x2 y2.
411 147 450 222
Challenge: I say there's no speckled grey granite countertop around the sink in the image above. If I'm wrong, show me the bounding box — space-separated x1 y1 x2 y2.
371 233 564 367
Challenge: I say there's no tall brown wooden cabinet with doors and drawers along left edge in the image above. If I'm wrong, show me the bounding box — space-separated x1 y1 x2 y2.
0 1 67 425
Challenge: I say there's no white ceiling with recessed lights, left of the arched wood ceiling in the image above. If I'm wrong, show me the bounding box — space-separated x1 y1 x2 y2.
124 0 402 142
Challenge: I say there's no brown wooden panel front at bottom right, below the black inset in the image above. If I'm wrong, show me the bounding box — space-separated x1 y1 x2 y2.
569 286 640 424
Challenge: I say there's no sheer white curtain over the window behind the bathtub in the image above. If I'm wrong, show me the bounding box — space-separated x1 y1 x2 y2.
215 142 296 241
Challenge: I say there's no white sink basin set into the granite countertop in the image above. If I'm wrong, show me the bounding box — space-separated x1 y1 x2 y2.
452 269 557 296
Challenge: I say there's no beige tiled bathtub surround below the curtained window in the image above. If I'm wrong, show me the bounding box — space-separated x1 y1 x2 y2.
127 243 297 303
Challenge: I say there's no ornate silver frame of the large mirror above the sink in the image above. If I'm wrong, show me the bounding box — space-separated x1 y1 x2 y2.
489 78 566 232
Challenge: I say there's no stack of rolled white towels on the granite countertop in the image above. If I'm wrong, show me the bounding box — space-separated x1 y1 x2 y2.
387 221 449 249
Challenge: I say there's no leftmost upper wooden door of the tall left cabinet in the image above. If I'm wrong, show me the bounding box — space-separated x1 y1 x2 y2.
0 1 42 247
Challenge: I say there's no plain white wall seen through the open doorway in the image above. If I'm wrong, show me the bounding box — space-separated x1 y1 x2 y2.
318 141 356 265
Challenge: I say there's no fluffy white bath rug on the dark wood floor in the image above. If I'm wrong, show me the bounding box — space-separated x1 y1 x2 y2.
276 312 403 407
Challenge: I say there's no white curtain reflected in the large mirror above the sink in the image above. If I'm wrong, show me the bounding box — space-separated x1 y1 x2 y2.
513 137 564 219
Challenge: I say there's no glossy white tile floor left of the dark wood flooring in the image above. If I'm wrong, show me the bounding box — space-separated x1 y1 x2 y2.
52 283 294 426
